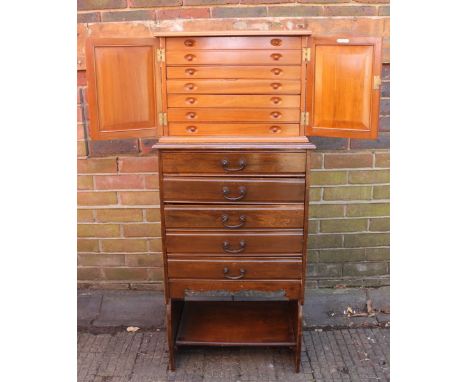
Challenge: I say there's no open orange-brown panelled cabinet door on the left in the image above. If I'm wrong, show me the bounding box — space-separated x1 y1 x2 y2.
86 38 160 139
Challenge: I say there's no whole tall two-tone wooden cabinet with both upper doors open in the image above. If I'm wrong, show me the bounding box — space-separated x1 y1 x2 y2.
87 31 381 371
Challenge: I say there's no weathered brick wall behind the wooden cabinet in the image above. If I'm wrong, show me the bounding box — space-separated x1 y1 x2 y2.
77 0 390 289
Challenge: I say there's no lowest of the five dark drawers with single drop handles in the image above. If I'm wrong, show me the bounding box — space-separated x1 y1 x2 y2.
168 257 302 280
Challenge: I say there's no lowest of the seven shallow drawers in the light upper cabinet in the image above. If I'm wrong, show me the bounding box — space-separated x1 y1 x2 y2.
168 122 300 137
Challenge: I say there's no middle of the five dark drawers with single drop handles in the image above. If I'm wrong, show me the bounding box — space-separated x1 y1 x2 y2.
164 204 304 230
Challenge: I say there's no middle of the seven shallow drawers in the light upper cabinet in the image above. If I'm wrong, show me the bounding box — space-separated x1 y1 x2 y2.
167 79 301 94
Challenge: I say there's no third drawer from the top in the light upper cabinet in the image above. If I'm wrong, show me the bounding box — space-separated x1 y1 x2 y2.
166 65 302 80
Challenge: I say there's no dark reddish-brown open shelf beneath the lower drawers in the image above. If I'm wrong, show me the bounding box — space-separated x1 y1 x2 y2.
175 301 296 346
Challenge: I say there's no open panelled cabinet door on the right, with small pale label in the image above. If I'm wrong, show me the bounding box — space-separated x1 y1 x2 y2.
306 37 382 139
